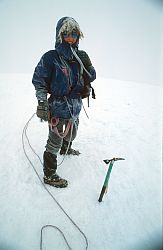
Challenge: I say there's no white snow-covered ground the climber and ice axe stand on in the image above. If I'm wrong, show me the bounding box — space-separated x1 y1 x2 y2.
0 74 162 250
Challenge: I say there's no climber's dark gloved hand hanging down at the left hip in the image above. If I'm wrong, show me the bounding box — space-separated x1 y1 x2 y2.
36 100 49 121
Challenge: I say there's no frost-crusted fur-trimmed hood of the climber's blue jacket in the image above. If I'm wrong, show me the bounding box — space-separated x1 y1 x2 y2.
55 17 84 47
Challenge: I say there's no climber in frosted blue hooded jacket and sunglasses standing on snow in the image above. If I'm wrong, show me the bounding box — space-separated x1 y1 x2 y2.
32 17 96 188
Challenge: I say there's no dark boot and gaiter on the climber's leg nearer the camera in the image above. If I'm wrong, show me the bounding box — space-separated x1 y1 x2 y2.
43 151 68 188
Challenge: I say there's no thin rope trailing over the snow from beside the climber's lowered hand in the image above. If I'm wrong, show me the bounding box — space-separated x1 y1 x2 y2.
22 113 88 250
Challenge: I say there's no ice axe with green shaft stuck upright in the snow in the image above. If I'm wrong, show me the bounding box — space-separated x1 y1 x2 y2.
98 158 125 202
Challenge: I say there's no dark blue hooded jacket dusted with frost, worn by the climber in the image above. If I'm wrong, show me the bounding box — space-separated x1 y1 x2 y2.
32 17 96 119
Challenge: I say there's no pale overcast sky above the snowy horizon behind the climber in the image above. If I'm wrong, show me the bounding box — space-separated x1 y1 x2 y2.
0 0 163 83
